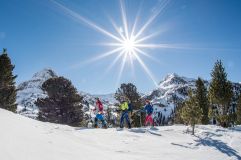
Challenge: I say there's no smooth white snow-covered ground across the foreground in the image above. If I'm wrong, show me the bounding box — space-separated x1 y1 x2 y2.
0 109 241 160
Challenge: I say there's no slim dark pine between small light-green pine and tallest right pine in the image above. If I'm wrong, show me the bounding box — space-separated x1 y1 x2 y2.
196 78 209 124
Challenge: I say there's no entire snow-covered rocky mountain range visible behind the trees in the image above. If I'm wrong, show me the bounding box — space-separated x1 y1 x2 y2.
17 69 241 118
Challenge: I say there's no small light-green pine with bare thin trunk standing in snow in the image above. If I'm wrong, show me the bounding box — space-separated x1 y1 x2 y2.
181 90 202 135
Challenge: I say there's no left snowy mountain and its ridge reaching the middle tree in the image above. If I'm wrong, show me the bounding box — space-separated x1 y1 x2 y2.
17 68 117 118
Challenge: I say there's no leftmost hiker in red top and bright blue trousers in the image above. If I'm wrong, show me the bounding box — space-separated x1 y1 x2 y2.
94 98 107 128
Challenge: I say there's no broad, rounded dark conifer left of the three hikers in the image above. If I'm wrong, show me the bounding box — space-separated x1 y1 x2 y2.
36 77 83 126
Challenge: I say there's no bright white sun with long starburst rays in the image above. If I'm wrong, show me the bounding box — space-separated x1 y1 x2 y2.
50 0 173 85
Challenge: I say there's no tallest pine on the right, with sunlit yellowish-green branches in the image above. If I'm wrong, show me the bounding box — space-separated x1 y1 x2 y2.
209 61 233 127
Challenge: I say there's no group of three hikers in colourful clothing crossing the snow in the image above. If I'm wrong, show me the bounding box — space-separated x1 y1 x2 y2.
93 98 154 129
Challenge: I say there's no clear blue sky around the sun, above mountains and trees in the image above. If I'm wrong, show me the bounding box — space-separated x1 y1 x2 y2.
0 0 241 94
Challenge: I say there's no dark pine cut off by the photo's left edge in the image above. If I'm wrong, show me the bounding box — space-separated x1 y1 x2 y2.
0 49 17 112
